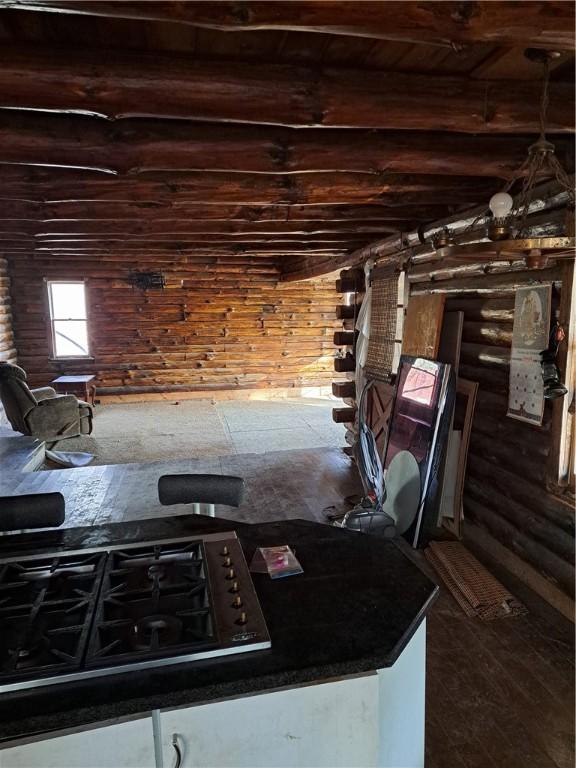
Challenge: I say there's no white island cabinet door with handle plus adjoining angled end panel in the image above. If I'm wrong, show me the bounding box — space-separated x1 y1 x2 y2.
156 621 426 768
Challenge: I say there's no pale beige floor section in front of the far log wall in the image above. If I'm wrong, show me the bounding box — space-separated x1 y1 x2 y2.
51 397 345 466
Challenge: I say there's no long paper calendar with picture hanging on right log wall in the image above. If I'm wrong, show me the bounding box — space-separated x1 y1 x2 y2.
508 284 552 426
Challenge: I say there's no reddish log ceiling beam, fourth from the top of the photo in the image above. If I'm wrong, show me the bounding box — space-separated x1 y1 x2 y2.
0 166 500 205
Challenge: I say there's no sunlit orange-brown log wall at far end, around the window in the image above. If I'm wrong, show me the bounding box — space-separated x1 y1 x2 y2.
10 256 341 394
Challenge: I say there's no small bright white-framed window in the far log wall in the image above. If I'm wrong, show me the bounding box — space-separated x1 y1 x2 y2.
47 280 90 357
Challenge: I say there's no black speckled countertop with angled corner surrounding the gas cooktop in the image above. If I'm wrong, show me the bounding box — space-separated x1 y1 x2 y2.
0 515 438 740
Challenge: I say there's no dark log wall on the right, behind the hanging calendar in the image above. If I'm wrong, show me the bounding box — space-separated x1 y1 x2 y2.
411 264 574 602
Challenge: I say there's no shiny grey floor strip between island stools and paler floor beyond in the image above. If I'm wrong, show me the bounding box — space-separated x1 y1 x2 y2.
0 448 361 527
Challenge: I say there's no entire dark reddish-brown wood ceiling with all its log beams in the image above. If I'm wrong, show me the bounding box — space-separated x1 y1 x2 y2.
0 0 575 274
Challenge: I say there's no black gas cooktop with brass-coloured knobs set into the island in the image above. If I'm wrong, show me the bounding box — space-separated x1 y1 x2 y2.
0 532 271 692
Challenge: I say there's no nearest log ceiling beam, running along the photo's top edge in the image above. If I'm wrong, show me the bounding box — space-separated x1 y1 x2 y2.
4 0 574 49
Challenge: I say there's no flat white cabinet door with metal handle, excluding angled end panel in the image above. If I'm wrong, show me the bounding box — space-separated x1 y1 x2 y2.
160 673 379 768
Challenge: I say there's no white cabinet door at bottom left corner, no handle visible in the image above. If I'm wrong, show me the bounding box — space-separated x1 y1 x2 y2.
0 717 156 768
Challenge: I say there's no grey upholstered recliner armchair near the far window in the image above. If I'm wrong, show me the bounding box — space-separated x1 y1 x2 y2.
0 362 92 440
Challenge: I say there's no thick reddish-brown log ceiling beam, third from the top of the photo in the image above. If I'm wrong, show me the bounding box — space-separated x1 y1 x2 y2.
0 112 573 178
